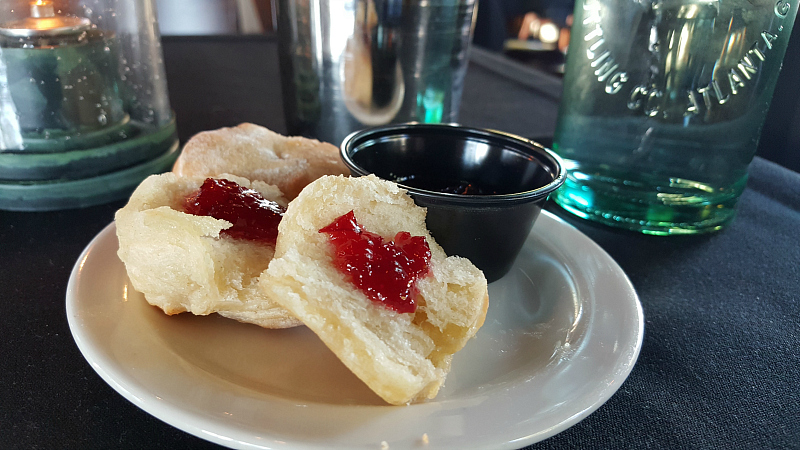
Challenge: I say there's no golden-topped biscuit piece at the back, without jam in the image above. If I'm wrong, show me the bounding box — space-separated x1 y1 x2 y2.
172 123 350 200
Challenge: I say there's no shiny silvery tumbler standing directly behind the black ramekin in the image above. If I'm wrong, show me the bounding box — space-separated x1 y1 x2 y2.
277 0 477 145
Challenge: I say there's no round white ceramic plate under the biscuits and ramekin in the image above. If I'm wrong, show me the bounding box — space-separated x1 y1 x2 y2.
67 212 643 450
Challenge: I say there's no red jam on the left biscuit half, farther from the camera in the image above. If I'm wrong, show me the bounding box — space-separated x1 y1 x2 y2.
184 178 286 245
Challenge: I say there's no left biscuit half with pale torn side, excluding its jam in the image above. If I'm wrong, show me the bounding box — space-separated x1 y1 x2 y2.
115 173 300 328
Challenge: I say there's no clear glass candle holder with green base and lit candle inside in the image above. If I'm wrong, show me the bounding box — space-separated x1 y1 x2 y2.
0 0 178 211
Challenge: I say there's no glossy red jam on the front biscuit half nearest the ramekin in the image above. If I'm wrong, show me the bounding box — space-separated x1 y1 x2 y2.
319 211 431 313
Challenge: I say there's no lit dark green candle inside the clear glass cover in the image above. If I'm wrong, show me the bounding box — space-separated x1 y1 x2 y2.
0 0 125 151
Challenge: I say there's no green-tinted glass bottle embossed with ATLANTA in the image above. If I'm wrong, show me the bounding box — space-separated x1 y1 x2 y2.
553 0 797 235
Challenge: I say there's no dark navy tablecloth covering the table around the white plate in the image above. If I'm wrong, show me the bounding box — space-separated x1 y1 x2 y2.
0 37 800 449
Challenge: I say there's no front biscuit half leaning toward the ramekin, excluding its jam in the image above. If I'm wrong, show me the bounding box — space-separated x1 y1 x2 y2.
260 176 488 404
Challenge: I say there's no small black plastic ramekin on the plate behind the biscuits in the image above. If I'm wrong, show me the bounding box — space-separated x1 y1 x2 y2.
340 123 565 282
